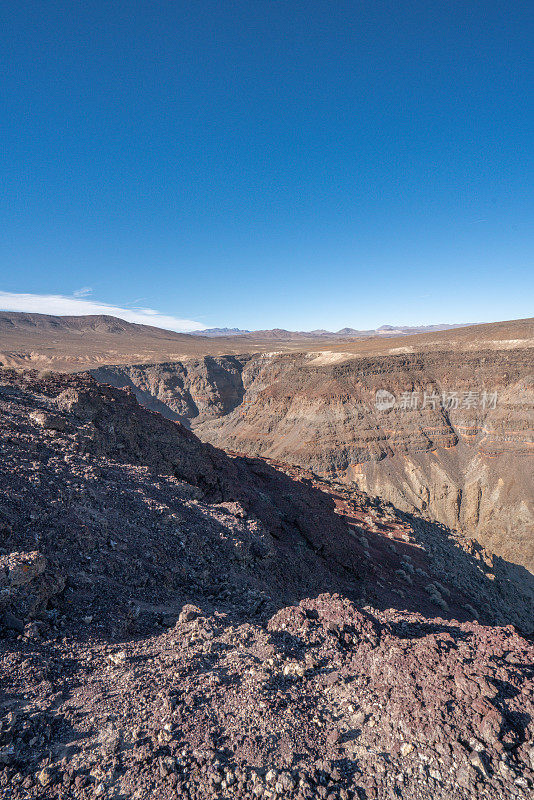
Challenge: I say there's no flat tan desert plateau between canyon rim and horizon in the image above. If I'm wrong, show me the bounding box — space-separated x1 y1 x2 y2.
0 311 534 372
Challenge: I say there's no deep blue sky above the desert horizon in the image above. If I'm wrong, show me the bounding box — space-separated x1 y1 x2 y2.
0 0 534 329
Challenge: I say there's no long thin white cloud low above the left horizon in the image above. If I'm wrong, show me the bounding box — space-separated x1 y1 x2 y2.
0 287 206 333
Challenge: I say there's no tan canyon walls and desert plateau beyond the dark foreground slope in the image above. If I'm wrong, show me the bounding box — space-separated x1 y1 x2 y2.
0 312 534 571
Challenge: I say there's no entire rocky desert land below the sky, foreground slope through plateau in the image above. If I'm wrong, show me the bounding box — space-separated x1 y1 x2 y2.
0 315 534 800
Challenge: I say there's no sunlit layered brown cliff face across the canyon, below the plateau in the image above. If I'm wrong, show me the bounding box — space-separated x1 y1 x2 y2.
93 348 534 571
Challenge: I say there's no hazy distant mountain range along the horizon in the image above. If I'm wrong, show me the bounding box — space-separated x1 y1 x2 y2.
196 322 472 339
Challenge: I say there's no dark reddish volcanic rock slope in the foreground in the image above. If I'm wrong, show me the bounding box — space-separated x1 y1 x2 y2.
0 370 534 800
